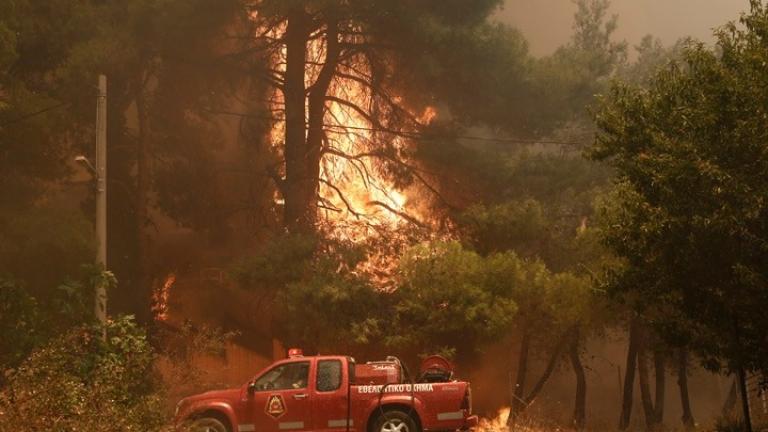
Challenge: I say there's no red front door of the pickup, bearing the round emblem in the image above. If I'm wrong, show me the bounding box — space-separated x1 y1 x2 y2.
250 360 313 432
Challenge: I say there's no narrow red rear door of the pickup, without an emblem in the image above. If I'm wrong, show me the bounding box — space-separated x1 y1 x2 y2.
312 359 356 432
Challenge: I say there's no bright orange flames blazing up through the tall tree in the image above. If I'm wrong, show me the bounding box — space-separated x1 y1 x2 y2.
260 15 437 242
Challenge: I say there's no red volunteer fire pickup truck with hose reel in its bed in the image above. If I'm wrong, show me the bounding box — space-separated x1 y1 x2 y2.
176 349 477 432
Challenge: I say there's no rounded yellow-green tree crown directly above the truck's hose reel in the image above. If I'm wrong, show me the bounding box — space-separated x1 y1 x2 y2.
387 242 522 360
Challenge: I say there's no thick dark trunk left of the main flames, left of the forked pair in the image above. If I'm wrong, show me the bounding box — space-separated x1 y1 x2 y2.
280 7 317 234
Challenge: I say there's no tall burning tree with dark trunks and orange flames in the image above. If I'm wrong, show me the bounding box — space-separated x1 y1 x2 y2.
242 0 516 234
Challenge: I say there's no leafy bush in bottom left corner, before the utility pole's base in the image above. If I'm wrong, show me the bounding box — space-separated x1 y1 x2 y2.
0 317 163 431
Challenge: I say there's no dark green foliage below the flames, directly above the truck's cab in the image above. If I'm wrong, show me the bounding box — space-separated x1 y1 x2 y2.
230 235 380 352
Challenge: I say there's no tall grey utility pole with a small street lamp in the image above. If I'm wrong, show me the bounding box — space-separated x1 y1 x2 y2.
95 75 107 324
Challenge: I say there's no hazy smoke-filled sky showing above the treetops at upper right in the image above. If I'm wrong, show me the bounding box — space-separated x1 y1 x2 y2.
498 0 749 56
